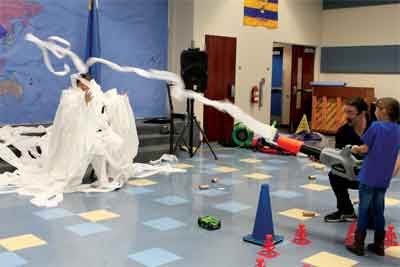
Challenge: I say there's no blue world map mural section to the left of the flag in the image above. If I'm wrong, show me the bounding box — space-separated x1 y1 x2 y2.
0 0 88 125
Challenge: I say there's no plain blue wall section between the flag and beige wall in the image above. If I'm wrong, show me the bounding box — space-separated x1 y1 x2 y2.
100 0 168 117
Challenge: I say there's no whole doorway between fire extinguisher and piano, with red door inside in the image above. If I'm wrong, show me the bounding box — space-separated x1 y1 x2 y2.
271 43 315 132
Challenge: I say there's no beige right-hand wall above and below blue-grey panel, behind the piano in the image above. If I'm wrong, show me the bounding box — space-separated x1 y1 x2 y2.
317 4 400 99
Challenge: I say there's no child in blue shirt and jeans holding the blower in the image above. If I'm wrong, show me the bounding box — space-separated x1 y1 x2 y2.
347 97 400 256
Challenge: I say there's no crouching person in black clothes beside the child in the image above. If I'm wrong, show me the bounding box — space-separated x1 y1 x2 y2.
324 97 370 222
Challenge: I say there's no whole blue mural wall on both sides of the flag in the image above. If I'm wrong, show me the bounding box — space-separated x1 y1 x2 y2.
0 0 168 124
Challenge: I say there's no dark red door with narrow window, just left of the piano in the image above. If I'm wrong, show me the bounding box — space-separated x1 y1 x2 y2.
290 45 315 131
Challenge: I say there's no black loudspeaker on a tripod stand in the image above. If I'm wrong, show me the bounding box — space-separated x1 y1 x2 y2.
181 48 208 93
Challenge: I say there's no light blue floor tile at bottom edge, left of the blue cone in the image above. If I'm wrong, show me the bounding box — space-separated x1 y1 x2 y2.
128 248 182 267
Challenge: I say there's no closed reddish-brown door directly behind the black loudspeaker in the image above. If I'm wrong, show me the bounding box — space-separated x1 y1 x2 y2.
204 35 236 144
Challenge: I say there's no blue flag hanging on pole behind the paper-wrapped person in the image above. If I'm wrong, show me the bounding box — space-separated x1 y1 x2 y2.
85 0 101 84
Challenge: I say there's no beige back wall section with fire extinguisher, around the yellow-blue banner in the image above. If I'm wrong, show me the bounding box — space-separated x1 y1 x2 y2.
193 0 322 125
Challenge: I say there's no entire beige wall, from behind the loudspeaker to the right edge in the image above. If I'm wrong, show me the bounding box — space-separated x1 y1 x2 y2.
169 0 400 127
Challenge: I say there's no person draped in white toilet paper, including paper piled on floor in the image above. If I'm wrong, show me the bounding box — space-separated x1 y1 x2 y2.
0 74 182 207
